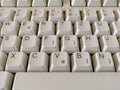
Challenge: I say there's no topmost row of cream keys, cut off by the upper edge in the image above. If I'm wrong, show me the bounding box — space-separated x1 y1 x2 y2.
1 0 120 7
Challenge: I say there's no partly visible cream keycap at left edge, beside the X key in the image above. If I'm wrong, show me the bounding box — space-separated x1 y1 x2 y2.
0 52 7 71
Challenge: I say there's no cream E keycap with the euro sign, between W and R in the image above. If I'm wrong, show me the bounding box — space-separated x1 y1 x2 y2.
19 21 37 37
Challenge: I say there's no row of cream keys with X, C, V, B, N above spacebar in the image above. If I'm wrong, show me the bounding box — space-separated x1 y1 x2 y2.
0 52 120 73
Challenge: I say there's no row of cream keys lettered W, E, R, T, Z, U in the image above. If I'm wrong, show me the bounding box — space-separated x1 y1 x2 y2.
0 21 120 38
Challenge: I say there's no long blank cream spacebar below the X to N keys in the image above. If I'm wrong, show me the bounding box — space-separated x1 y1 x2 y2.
12 73 120 90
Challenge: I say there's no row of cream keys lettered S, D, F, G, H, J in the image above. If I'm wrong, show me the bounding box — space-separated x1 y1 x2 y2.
0 35 120 54
